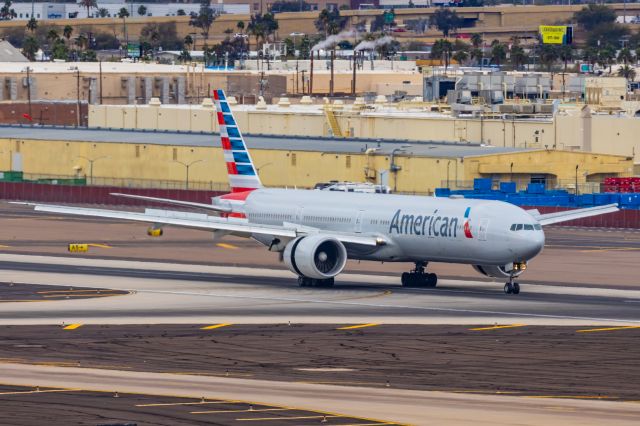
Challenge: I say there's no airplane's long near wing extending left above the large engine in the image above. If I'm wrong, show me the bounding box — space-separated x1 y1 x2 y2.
21 203 386 246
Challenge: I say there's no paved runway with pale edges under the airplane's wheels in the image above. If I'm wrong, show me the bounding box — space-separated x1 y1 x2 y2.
0 254 640 325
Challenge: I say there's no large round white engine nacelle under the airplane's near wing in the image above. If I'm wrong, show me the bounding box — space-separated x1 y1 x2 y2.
282 235 347 280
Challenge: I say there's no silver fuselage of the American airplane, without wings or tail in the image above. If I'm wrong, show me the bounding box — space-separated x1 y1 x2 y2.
244 189 545 265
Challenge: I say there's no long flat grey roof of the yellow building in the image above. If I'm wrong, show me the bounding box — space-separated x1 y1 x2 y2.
0 126 531 158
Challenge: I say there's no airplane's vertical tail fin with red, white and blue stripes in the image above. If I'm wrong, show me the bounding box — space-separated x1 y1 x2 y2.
213 90 262 192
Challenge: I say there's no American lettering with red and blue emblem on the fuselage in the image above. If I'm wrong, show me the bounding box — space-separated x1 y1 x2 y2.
389 208 473 238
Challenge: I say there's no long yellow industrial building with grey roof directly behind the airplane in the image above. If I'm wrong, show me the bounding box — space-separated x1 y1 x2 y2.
0 128 633 194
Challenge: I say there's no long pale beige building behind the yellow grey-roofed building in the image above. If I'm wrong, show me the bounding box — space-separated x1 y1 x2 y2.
89 98 640 172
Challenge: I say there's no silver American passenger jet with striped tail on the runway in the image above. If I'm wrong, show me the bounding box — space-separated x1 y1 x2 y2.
20 90 618 294
